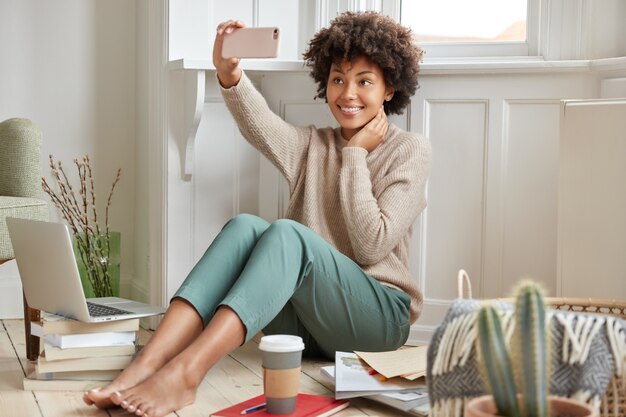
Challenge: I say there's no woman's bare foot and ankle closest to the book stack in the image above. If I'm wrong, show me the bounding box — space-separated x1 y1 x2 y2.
83 356 159 408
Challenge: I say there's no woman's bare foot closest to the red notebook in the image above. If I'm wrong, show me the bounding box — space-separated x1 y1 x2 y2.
111 361 198 417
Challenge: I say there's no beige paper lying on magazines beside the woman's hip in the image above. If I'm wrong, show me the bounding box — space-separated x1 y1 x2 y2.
355 345 428 380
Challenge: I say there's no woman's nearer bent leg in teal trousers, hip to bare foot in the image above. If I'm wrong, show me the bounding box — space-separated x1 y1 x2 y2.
107 220 409 417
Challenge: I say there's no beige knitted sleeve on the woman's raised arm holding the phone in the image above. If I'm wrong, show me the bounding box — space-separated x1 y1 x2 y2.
218 73 313 188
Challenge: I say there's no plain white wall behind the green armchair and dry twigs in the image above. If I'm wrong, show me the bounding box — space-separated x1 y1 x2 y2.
0 0 136 316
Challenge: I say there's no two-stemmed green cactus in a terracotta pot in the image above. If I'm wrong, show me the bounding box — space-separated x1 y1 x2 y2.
465 281 594 417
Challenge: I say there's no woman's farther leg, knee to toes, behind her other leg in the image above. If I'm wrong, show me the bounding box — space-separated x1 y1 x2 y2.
83 214 269 408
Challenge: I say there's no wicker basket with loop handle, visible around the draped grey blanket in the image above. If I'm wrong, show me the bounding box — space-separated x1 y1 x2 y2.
458 270 626 417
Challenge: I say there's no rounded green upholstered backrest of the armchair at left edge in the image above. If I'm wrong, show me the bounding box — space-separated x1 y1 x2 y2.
0 118 42 198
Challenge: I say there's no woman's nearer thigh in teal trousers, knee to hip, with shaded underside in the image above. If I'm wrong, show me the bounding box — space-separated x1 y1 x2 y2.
263 223 411 359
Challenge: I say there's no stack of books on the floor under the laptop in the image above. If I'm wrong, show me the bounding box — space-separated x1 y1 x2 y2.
24 314 139 391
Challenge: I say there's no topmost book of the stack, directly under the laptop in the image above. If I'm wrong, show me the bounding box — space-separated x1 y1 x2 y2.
31 313 139 337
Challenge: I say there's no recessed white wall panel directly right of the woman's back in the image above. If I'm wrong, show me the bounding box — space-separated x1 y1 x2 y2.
420 100 488 300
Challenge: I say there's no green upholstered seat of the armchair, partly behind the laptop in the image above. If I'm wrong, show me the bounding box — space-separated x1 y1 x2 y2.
0 197 48 259
